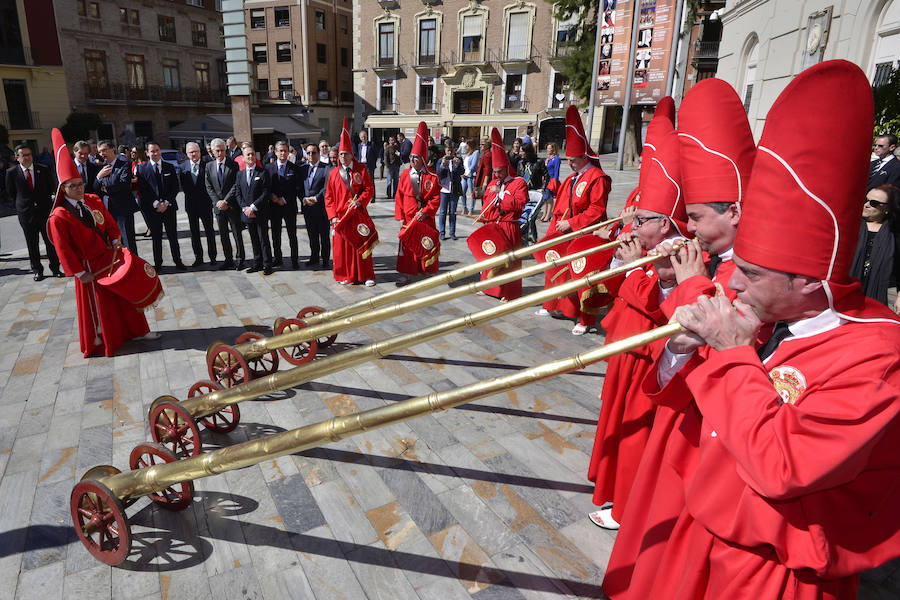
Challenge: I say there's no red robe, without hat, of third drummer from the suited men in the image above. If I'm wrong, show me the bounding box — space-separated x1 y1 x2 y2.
479 177 528 300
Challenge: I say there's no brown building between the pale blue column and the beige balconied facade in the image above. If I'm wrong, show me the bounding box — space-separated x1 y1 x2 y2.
244 0 359 140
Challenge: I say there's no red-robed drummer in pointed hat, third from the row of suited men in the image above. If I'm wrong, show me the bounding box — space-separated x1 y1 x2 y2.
475 127 528 300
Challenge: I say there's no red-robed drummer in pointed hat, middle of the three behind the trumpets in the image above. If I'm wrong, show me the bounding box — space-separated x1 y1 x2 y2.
394 121 441 285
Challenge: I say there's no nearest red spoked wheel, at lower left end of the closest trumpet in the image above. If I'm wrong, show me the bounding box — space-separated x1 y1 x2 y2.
69 479 131 566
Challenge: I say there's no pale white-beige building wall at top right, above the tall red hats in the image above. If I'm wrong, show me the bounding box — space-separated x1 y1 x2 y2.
717 0 900 138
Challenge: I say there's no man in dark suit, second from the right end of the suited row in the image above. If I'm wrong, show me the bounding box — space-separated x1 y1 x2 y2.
266 142 300 270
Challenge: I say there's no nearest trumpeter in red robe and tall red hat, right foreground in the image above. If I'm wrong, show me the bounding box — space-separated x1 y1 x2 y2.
604 61 900 600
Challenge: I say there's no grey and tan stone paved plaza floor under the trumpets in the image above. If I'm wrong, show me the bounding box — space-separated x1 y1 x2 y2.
0 158 900 600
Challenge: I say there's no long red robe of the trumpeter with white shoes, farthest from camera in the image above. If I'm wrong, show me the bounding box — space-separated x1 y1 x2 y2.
588 269 666 521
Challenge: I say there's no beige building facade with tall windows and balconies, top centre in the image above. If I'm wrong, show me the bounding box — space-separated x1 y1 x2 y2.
353 0 578 143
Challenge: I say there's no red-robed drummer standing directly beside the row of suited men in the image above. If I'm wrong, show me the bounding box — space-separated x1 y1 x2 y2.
325 117 375 287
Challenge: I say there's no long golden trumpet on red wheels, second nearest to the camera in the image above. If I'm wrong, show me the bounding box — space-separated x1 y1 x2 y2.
148 246 659 456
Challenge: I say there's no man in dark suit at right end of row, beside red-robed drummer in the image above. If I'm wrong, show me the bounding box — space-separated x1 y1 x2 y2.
297 144 331 269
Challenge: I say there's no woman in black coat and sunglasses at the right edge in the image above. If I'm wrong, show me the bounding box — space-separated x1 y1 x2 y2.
850 184 900 313
